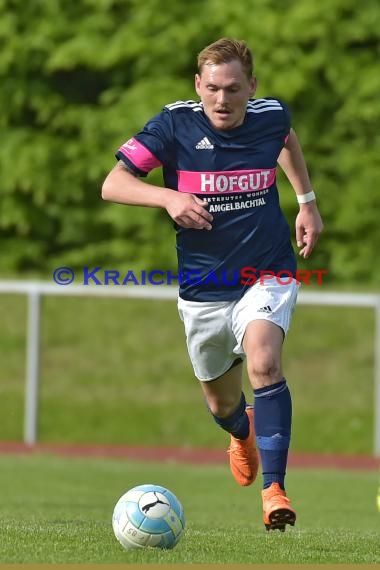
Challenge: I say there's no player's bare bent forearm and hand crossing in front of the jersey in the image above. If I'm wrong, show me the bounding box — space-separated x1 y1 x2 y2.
102 160 213 230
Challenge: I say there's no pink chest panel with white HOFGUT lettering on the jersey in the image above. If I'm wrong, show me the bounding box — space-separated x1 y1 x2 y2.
177 168 276 195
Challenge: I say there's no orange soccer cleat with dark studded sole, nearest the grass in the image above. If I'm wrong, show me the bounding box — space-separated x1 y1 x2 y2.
261 483 296 532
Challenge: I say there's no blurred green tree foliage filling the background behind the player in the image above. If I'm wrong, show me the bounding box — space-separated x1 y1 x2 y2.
0 0 380 283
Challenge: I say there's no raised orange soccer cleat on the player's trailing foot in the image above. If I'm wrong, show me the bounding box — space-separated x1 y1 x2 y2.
227 406 259 487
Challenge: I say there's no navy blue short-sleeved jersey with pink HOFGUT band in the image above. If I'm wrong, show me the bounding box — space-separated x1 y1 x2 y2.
116 98 296 301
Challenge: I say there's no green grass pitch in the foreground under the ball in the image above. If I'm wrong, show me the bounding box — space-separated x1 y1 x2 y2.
0 456 380 564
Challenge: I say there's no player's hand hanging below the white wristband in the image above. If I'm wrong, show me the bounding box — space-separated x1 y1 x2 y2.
296 202 323 259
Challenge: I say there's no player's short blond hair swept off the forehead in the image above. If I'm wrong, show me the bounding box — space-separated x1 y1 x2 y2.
198 38 253 79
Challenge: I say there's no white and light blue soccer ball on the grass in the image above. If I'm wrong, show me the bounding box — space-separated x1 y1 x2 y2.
112 485 185 549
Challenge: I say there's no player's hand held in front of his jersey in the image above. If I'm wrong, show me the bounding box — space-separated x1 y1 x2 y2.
166 192 213 230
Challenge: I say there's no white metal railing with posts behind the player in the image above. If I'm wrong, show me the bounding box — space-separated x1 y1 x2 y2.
0 281 380 456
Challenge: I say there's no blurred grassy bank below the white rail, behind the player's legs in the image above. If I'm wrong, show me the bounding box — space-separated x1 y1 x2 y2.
0 288 374 453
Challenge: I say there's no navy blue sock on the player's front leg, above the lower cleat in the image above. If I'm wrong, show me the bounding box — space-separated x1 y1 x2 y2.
253 378 292 489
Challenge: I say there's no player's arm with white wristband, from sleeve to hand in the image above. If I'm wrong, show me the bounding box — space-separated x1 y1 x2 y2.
278 129 323 258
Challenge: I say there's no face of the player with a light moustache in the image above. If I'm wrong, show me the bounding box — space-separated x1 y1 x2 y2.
195 60 256 130
